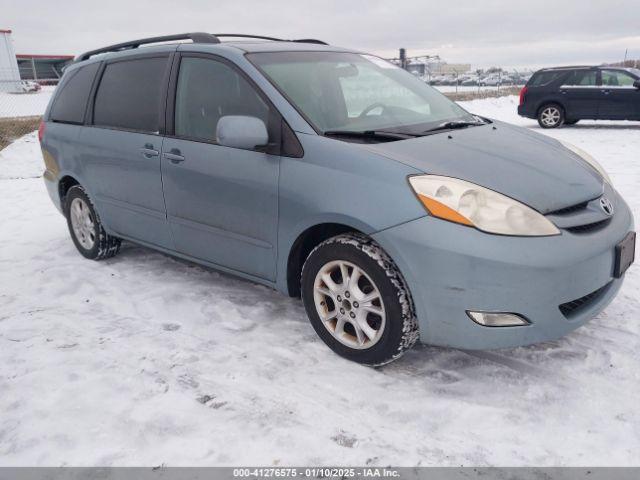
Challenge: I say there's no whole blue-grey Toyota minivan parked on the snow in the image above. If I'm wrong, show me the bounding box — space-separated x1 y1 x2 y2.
39 33 635 365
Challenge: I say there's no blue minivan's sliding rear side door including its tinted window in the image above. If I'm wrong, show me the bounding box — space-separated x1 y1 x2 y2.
79 54 173 249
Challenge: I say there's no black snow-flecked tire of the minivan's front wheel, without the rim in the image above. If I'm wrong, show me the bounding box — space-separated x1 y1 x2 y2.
301 233 418 366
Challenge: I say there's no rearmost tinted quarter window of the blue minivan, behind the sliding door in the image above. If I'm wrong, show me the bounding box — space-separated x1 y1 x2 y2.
49 63 100 124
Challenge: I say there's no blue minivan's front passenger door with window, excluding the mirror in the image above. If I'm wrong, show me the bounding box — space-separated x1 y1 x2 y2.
162 54 280 280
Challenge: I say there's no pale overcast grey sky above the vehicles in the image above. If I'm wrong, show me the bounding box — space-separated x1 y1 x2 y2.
5 0 640 67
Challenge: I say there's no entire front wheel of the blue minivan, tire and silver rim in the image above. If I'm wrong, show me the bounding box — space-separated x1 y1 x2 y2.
302 234 418 366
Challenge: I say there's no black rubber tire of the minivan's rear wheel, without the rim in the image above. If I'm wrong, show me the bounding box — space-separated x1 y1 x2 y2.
64 185 121 260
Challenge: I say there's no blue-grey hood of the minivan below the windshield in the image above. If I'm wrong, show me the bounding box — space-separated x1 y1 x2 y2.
361 121 603 213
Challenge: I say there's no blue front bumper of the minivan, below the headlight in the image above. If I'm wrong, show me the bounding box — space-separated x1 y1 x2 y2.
373 190 633 349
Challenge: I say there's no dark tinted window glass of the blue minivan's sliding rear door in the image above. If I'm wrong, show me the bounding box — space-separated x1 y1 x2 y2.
93 57 168 133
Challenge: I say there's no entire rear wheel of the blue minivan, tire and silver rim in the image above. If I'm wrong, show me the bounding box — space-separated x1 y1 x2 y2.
65 185 120 260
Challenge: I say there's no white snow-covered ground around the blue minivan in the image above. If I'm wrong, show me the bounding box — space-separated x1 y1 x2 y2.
0 97 640 466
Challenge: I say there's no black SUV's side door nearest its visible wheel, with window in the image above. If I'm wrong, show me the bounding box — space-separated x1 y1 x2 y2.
560 69 600 120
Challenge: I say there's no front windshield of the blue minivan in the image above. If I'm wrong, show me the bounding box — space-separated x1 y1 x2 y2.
247 52 478 134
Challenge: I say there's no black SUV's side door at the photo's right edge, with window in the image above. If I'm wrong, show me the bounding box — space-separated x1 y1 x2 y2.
598 70 640 120
